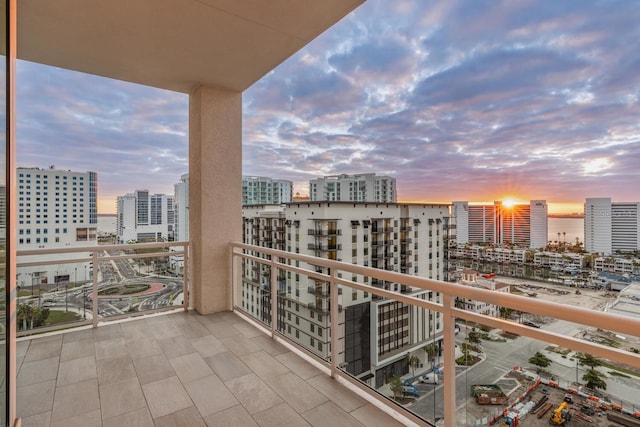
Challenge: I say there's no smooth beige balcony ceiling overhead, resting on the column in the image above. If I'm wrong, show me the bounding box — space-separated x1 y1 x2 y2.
18 0 364 93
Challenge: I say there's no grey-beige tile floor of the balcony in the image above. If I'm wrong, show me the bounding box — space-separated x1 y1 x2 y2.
17 312 401 427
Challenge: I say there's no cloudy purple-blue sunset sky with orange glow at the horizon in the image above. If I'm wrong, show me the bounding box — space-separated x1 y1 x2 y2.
17 0 640 213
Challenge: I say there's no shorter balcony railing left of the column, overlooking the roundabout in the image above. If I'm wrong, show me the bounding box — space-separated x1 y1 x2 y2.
17 242 189 336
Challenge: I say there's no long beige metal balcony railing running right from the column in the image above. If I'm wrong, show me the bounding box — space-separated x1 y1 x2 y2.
231 243 640 426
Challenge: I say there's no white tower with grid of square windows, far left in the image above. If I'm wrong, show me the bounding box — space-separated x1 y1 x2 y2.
17 166 98 287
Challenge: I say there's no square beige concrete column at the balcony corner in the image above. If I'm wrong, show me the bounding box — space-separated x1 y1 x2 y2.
189 86 242 314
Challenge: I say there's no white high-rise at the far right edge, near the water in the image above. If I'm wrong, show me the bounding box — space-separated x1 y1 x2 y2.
584 197 640 255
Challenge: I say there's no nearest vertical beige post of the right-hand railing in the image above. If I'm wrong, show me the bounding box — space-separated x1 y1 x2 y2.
442 294 456 427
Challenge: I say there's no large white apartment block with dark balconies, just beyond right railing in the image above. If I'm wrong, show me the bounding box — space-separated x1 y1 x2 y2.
242 202 449 386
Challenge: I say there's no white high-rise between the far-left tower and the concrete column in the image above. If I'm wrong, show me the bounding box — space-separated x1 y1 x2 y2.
116 190 175 243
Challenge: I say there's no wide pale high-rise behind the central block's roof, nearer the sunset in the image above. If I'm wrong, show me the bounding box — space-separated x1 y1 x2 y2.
309 173 397 203
